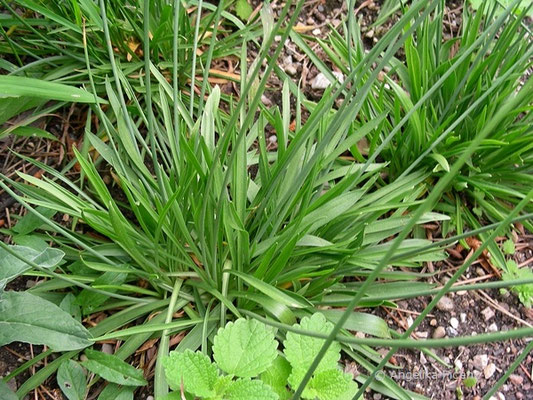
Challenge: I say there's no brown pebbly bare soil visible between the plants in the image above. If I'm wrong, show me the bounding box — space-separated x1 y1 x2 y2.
0 0 533 400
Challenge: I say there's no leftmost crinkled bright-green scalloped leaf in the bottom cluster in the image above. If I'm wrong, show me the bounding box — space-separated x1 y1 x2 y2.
163 349 218 397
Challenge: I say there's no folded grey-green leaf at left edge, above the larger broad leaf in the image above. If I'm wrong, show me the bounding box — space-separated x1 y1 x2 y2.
0 246 65 290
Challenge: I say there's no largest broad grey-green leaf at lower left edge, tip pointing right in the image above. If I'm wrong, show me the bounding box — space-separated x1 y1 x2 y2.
0 291 92 351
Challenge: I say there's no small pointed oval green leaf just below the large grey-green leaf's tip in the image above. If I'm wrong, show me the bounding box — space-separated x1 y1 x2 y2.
82 350 147 386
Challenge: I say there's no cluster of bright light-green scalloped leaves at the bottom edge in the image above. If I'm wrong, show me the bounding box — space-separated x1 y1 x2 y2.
163 313 358 400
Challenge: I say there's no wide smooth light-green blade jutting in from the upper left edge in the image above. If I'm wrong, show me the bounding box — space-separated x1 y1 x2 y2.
0 75 96 103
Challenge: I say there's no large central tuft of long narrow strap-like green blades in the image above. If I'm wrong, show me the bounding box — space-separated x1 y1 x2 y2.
0 0 533 399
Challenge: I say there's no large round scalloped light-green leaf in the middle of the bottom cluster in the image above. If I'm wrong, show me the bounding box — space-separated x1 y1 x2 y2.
213 318 278 378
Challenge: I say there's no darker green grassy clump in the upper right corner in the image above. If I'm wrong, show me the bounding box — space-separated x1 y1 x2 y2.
295 2 533 300
